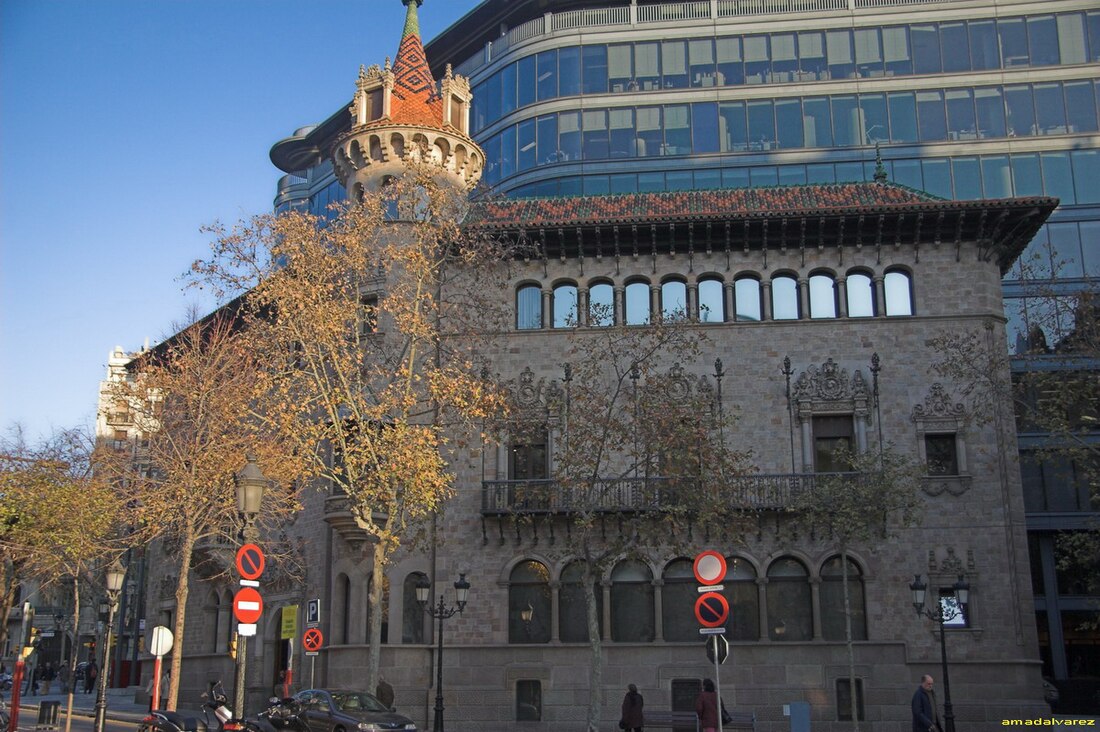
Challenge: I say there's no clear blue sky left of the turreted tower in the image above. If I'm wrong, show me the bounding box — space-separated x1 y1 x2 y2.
0 0 477 437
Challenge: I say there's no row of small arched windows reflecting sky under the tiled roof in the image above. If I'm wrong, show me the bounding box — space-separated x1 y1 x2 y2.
516 267 913 330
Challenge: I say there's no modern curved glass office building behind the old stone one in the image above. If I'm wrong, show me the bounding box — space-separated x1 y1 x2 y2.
272 0 1100 701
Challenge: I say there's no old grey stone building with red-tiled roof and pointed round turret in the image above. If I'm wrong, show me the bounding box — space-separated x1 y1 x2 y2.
113 0 1057 732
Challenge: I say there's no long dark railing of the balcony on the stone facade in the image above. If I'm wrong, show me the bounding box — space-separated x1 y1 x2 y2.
482 473 866 516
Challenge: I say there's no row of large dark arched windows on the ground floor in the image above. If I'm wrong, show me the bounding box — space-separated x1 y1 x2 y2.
508 556 867 643
